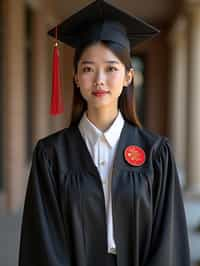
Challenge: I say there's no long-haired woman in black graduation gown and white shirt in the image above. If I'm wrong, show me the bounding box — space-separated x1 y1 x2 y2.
19 1 190 266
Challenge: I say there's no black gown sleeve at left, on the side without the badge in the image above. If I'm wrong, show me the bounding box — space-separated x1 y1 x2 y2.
18 141 69 266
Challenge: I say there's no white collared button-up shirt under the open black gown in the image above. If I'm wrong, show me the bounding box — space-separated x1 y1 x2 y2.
78 111 124 254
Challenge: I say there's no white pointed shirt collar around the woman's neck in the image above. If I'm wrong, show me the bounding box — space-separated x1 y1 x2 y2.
78 111 124 147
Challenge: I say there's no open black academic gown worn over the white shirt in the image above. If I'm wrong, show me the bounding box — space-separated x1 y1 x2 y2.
19 121 190 266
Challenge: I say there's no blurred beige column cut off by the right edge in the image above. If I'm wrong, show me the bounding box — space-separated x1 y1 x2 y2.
187 1 200 195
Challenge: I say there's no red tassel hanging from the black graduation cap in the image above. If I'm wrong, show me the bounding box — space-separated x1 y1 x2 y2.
50 42 64 115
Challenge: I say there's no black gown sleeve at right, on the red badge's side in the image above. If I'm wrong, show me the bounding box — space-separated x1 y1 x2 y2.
145 137 190 266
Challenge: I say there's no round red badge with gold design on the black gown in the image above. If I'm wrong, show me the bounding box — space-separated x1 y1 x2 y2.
124 145 146 166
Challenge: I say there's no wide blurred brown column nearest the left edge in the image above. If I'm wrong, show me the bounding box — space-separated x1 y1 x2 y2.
2 0 26 211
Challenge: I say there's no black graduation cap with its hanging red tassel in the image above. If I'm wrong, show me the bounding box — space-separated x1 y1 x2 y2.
48 0 159 115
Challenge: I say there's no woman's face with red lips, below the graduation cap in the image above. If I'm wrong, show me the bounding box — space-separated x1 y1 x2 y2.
75 43 133 112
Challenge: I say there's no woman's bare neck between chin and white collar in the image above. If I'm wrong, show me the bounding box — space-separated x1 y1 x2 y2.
86 108 118 132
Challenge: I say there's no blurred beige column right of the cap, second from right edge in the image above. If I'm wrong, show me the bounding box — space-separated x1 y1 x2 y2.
168 16 187 188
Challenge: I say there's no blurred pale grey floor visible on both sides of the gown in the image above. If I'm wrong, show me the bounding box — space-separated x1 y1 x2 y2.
0 198 200 266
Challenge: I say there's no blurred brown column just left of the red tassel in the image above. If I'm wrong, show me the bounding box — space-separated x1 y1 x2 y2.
31 7 49 146
